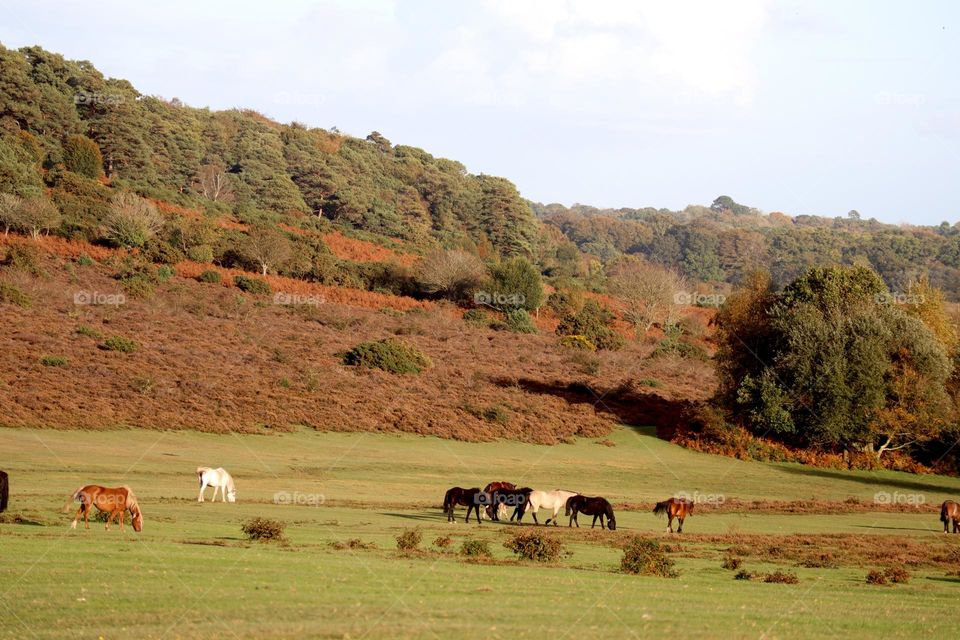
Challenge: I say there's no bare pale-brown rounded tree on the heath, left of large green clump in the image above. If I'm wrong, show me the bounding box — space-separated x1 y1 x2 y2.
609 258 686 332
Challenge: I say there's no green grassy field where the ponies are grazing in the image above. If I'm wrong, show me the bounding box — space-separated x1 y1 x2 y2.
0 428 960 638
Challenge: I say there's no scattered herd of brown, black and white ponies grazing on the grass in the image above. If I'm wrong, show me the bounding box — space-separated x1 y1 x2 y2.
0 467 960 533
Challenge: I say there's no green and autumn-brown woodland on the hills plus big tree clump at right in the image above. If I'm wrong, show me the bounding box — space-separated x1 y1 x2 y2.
0 46 960 465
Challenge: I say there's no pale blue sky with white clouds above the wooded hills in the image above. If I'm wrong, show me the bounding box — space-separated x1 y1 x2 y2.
0 0 960 224
